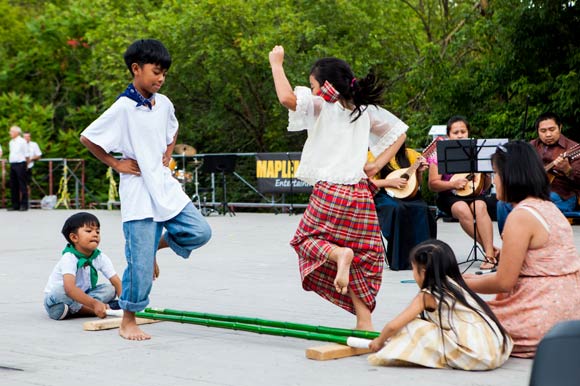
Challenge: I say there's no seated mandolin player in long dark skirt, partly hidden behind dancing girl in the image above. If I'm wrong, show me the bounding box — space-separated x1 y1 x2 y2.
373 141 437 271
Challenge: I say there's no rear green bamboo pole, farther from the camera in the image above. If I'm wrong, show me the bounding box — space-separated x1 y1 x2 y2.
145 308 379 339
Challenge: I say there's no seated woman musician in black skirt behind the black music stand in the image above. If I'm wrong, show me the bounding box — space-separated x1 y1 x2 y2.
427 116 499 269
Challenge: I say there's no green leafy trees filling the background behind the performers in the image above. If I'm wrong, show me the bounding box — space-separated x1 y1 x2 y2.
0 0 580 205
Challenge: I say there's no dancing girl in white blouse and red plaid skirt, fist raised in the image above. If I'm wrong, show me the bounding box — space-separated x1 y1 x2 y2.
269 46 407 330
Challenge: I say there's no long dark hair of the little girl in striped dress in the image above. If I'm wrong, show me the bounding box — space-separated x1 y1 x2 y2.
410 239 508 358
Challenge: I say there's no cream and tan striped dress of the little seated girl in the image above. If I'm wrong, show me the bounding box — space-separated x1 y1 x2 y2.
368 282 512 370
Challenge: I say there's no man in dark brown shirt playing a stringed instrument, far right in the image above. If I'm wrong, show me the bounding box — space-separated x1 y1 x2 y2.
497 112 580 233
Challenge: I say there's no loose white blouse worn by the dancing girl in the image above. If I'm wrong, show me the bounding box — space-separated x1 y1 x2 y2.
288 86 408 185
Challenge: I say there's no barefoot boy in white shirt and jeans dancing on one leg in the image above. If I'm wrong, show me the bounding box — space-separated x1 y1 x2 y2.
81 39 211 340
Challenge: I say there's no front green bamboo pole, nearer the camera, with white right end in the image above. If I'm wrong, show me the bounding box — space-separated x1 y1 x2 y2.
135 312 360 345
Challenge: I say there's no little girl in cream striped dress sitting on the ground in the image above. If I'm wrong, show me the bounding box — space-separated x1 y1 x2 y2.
369 240 512 370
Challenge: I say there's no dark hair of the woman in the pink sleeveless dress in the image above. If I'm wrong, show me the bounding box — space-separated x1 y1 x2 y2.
491 141 550 202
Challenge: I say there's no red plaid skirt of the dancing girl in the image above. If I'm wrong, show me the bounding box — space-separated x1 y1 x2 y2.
290 180 385 314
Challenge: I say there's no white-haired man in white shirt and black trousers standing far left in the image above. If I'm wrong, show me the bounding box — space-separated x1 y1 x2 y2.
8 126 28 211
